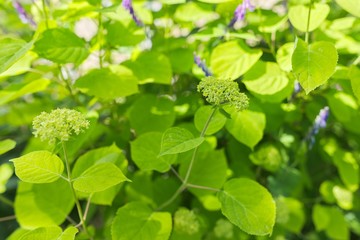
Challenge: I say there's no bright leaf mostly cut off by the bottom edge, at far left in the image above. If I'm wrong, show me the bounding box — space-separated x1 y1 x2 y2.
19 226 78 240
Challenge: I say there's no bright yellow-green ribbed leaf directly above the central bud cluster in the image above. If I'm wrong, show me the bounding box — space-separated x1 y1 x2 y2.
210 40 262 80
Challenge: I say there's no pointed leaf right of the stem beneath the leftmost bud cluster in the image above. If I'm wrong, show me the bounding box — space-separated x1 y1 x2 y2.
73 162 129 193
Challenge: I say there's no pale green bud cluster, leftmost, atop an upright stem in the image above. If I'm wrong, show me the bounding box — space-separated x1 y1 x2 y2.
33 108 90 144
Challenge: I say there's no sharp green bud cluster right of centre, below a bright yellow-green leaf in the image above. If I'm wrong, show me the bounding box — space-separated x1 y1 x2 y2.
198 77 249 111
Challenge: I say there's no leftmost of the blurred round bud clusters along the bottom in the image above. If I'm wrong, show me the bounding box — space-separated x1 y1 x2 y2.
174 208 200 235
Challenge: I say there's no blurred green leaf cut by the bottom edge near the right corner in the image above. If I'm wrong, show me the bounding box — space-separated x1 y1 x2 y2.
312 204 349 240
